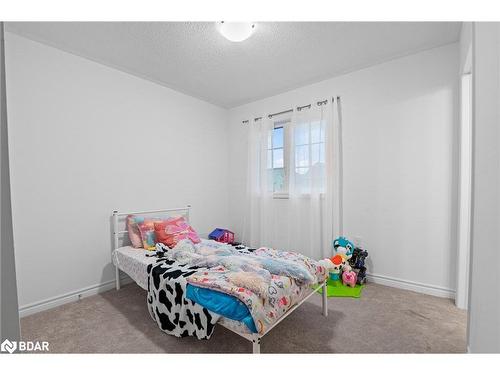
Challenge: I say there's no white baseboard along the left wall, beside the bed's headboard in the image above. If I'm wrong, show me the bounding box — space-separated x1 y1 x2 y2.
19 276 132 318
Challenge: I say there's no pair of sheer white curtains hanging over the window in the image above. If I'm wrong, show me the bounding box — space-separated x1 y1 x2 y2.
243 100 341 259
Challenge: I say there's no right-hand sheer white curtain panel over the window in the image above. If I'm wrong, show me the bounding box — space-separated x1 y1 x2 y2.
287 105 333 259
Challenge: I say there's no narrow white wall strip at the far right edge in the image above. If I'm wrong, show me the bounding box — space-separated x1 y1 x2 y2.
468 22 500 353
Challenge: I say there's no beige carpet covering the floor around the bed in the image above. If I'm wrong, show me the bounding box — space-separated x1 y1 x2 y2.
21 284 466 353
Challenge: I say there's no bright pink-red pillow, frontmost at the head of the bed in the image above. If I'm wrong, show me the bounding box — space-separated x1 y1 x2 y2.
154 216 201 248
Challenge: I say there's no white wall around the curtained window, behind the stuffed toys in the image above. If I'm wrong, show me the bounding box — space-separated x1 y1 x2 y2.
229 44 459 296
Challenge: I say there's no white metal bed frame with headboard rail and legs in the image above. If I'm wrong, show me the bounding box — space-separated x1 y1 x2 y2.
112 205 328 354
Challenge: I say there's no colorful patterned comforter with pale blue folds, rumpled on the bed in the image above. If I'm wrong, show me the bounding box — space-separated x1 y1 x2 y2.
170 243 327 333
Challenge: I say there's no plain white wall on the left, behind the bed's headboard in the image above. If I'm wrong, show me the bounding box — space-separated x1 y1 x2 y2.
6 33 228 309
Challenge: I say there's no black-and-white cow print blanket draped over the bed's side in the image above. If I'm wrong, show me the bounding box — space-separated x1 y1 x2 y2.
147 259 220 339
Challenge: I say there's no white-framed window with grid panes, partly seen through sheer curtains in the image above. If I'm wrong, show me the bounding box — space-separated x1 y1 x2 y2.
267 119 325 197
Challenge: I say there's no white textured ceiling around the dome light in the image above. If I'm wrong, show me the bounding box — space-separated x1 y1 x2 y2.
7 22 460 108
